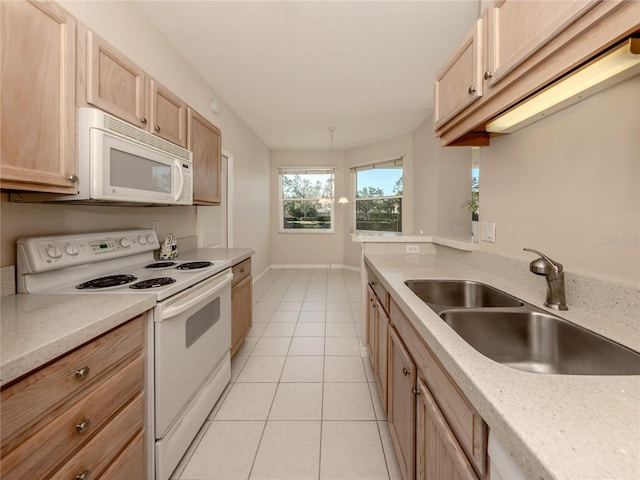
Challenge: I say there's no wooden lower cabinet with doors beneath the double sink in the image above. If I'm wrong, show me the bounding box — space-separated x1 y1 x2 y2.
387 299 489 480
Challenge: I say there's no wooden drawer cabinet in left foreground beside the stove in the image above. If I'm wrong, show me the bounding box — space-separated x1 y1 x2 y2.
0 316 146 480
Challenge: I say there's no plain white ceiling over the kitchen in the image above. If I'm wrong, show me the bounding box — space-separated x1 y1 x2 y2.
136 0 479 149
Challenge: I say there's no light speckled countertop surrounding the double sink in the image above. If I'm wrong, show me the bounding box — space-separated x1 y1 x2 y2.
366 253 640 480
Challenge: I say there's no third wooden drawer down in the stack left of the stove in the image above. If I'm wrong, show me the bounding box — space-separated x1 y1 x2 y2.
51 394 145 480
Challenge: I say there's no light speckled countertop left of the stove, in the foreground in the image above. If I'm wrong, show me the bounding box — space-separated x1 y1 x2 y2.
0 294 156 385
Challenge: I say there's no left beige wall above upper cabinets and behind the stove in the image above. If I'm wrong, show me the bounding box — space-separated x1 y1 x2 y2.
1 1 271 273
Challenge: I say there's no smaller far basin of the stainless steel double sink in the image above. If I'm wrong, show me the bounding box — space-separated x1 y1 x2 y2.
404 280 523 313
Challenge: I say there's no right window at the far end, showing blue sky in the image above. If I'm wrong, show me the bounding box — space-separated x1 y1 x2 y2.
352 157 403 232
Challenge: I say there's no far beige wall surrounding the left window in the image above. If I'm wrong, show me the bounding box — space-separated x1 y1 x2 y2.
270 150 351 265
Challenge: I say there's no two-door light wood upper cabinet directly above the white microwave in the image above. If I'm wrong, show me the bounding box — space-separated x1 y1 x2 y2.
78 30 187 148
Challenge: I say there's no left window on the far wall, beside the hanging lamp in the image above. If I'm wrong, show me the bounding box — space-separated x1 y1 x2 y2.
280 167 334 233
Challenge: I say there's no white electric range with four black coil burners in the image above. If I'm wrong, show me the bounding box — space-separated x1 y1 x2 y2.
16 229 233 480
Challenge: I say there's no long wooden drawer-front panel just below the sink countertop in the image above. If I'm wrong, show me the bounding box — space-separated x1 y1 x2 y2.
391 301 488 476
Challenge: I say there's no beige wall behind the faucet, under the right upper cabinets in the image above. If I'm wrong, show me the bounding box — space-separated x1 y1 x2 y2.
480 78 640 285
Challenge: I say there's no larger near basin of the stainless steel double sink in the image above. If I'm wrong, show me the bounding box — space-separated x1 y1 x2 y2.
440 312 640 375
